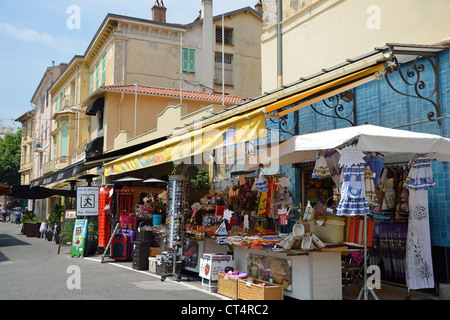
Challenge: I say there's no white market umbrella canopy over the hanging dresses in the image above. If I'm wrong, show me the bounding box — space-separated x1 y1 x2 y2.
245 124 450 170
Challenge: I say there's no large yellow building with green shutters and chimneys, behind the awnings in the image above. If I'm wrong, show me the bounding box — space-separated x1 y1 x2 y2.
37 0 262 185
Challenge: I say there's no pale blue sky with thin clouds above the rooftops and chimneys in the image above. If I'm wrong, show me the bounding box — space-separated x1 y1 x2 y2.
0 0 257 128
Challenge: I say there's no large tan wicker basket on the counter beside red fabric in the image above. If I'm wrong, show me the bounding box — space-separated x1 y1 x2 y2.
310 217 345 244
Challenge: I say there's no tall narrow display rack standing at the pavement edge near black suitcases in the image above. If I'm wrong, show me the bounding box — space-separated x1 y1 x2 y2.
161 175 189 281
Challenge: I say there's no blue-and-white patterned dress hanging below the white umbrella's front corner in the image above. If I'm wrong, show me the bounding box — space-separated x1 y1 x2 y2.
337 164 369 215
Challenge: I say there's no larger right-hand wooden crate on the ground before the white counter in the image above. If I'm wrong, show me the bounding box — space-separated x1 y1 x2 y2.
238 279 284 300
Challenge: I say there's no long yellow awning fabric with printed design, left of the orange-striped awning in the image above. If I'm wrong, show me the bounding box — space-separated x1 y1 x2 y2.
104 109 267 176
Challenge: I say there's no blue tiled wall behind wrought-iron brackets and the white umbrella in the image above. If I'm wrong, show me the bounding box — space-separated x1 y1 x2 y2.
288 50 450 247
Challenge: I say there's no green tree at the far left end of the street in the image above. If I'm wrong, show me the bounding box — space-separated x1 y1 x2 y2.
0 129 22 185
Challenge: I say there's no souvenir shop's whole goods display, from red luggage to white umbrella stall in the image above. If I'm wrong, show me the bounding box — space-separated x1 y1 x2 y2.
99 125 450 300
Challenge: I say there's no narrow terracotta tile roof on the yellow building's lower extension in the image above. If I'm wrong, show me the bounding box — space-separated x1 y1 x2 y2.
100 84 248 104
